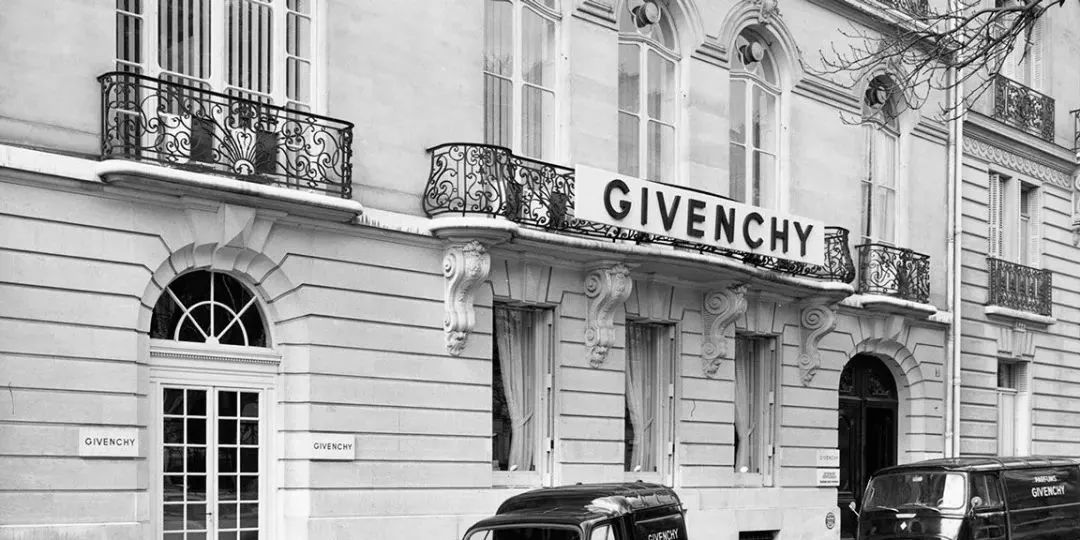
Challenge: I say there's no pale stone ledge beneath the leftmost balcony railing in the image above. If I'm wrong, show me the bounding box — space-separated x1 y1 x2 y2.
94 160 364 222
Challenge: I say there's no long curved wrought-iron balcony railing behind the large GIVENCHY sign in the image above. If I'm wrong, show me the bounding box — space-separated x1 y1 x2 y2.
423 143 855 283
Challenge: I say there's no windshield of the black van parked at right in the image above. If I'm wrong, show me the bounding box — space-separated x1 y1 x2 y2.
863 472 967 510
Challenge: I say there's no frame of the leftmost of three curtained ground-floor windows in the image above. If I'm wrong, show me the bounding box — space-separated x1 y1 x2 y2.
489 301 556 487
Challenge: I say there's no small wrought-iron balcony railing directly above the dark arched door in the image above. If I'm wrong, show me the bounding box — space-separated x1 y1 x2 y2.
855 244 930 303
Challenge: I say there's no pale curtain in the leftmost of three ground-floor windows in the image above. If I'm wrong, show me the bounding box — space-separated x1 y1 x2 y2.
495 308 537 471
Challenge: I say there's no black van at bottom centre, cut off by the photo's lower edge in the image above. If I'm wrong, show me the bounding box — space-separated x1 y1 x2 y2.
464 482 686 540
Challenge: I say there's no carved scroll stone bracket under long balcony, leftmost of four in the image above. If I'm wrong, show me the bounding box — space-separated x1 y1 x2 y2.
443 240 491 356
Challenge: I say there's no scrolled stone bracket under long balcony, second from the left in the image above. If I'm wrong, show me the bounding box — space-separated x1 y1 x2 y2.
585 264 634 367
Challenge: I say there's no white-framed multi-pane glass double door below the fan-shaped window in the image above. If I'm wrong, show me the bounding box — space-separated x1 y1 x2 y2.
157 384 266 540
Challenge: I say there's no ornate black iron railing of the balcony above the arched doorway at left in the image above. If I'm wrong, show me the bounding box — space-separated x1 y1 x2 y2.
98 71 352 199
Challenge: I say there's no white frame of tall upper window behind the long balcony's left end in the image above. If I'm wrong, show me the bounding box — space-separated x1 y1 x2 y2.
481 0 566 162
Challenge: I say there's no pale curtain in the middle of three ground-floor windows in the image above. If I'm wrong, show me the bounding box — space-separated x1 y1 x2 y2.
625 324 663 472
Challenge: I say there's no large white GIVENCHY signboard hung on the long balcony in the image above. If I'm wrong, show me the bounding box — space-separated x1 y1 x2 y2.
573 165 825 265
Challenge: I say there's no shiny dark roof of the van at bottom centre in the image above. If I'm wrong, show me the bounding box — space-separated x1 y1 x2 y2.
464 482 681 528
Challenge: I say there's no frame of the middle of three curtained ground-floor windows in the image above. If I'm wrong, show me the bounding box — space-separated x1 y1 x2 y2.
623 319 678 486
